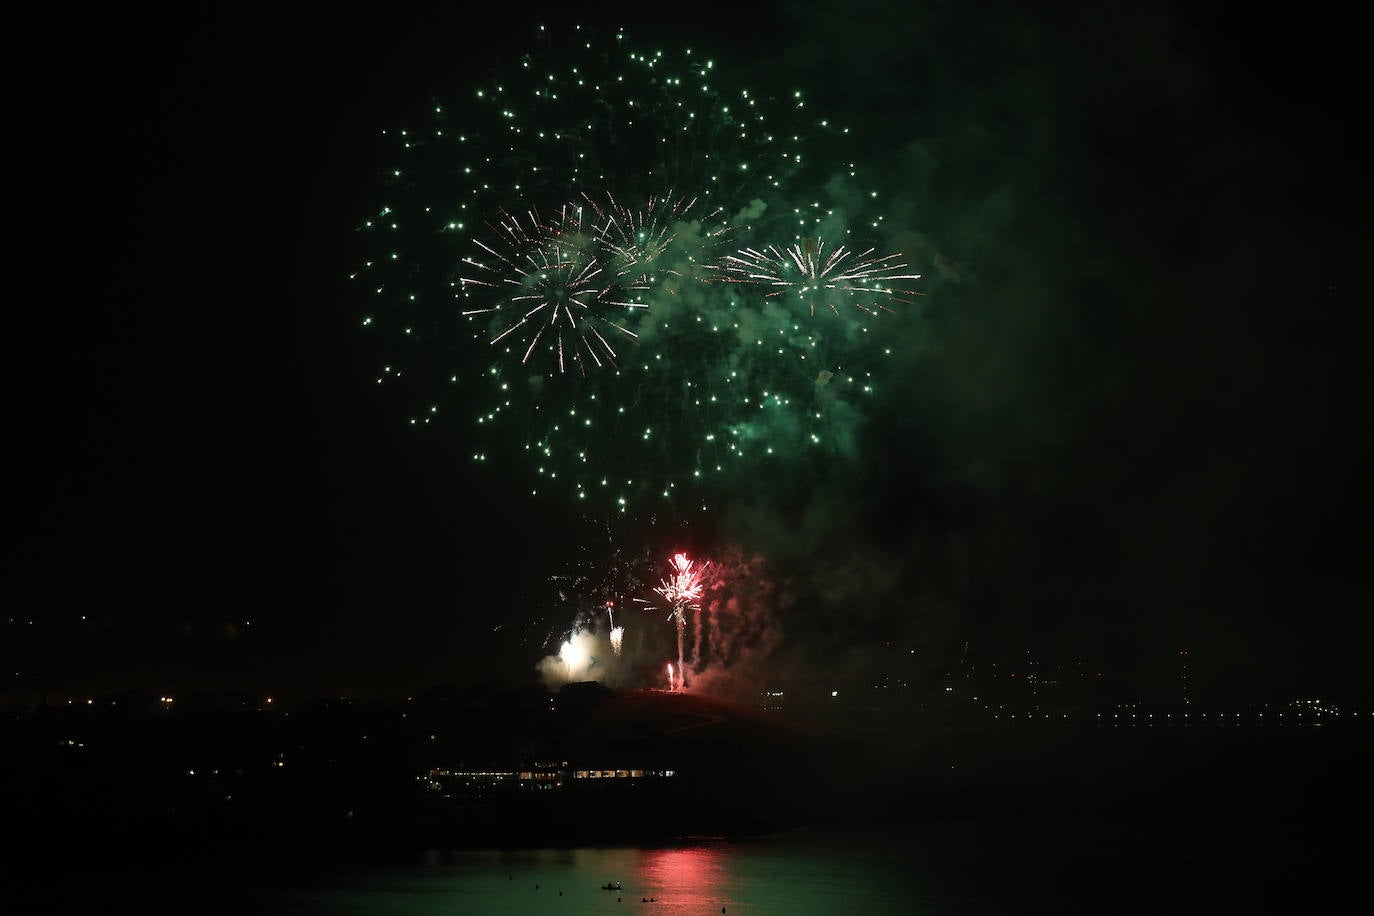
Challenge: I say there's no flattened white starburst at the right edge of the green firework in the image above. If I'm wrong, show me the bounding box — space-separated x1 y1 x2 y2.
716 239 921 314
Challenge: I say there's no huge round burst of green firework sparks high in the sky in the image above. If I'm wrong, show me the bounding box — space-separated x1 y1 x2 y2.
352 27 918 516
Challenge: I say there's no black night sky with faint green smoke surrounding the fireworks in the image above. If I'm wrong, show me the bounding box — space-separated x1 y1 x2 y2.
13 3 1374 699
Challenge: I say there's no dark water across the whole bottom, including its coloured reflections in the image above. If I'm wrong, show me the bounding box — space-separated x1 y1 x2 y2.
11 823 1352 916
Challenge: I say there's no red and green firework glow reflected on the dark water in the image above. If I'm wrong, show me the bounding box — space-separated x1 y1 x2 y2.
276 840 923 916
